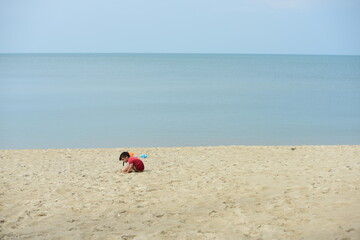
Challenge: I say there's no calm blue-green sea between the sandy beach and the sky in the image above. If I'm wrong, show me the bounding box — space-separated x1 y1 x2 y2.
0 54 360 149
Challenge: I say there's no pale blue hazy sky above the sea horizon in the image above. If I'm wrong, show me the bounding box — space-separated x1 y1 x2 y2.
0 0 360 55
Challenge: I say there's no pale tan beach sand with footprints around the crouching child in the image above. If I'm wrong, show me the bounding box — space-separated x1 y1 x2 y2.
0 146 360 240
